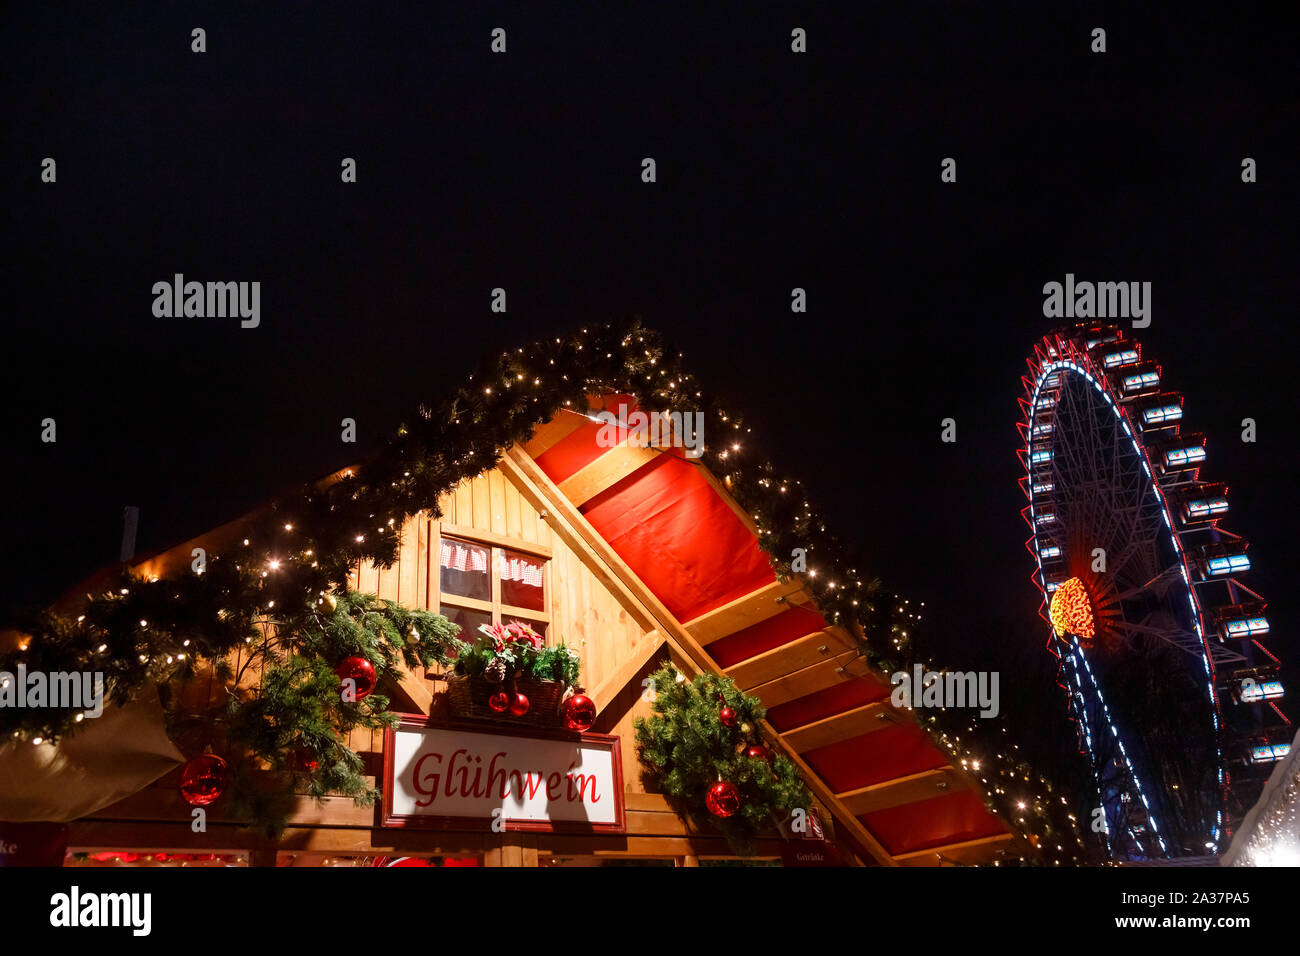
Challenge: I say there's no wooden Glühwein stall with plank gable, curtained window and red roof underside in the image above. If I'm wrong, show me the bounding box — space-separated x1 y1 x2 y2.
5 387 1013 866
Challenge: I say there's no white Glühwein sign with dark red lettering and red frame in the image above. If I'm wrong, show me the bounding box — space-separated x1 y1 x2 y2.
384 718 624 832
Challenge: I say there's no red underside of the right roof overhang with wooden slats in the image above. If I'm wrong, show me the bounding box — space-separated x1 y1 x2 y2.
503 411 1013 865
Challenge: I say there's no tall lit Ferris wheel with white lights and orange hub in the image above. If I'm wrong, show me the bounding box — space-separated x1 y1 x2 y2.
1019 324 1290 860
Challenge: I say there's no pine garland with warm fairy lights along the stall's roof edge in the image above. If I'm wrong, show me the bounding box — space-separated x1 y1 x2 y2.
0 320 1076 858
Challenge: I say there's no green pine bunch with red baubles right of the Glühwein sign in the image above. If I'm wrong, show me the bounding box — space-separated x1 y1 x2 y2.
633 663 813 856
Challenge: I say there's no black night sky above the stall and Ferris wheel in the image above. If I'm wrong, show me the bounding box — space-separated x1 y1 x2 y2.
0 3 1300 770
